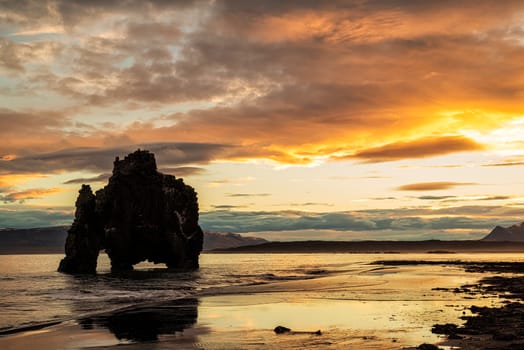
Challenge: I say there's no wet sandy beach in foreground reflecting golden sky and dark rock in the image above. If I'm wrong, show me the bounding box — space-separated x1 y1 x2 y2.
0 254 520 350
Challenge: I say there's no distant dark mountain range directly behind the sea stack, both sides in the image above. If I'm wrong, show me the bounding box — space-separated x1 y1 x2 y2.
0 226 267 254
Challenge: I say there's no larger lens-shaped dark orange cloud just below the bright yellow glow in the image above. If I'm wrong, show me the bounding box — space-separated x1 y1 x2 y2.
349 136 484 162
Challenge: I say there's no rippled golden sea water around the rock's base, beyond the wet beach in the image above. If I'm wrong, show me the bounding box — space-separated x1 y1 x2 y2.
0 254 524 330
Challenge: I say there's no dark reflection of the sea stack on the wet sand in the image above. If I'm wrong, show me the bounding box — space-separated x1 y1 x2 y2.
80 298 198 342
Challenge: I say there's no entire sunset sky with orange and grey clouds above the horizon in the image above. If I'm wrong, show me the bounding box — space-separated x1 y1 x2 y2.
0 0 524 240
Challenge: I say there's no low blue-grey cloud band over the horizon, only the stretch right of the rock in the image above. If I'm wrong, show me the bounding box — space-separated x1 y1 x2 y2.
200 206 522 239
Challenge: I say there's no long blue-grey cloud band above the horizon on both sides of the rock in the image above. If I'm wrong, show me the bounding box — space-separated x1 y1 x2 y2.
0 205 522 240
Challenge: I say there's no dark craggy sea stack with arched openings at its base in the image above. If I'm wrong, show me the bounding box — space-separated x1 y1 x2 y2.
58 150 203 273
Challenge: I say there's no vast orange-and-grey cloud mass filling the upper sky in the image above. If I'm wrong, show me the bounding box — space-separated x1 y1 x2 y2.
0 1 524 164
